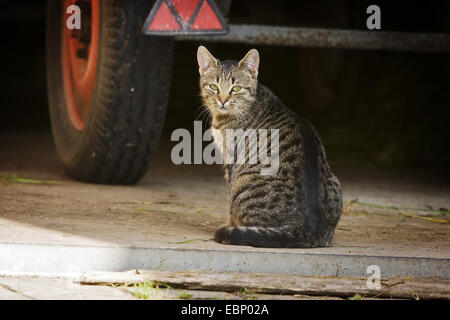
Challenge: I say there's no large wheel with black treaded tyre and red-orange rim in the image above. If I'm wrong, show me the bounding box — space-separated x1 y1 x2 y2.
47 0 173 184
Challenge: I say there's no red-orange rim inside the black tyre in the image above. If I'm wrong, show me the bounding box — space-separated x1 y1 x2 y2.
61 0 100 130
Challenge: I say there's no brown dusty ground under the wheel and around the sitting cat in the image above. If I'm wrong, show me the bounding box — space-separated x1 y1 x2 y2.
0 133 450 258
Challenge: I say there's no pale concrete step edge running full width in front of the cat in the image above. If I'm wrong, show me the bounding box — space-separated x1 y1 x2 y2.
0 243 450 279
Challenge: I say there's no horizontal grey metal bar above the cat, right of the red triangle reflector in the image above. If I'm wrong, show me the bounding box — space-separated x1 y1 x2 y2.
175 24 450 52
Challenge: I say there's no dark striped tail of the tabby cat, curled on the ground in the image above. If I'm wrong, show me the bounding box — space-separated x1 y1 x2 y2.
214 226 298 248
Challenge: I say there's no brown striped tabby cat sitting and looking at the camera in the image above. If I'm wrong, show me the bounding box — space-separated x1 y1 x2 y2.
197 46 342 248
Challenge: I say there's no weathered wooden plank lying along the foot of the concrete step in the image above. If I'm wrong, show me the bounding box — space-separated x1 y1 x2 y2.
81 270 450 299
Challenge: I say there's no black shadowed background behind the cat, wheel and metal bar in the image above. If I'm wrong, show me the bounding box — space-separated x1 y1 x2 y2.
0 1 450 167
